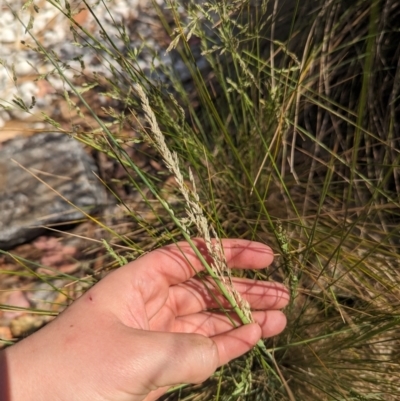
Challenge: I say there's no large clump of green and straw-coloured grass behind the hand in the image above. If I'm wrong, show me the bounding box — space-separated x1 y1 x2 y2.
3 0 400 401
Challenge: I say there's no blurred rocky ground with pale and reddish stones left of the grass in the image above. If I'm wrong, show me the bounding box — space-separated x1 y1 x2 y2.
0 0 181 347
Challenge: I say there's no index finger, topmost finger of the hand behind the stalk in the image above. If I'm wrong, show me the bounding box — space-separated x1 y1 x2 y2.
134 239 273 286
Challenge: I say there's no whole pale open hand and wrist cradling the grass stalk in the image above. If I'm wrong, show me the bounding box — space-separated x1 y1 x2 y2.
0 239 289 401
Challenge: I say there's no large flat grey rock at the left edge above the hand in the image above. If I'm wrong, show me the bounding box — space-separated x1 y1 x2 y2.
0 133 106 250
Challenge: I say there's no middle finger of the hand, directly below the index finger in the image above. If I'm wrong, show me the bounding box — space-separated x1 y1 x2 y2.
168 278 289 316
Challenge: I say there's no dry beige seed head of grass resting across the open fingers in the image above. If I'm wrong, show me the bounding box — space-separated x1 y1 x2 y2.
135 85 254 324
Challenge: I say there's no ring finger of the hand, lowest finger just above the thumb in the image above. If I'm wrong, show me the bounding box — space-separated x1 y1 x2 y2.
173 311 286 338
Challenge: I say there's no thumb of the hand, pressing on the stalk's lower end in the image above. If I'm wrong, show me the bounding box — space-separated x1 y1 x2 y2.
144 324 261 388
